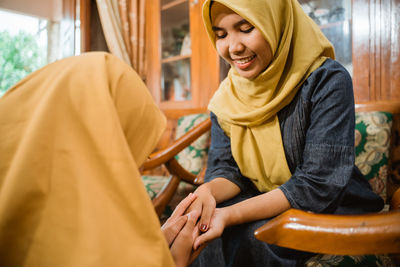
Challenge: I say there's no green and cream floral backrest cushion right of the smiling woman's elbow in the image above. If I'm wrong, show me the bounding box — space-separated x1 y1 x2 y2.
355 112 392 200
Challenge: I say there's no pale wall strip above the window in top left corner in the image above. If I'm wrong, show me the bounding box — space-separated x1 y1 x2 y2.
0 0 62 23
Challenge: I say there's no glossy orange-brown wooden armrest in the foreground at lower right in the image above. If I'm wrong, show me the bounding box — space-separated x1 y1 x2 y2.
255 209 400 255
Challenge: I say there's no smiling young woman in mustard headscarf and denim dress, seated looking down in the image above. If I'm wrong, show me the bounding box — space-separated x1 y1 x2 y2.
190 0 383 267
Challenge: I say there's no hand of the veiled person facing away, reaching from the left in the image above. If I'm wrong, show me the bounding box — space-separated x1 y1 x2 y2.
161 193 196 246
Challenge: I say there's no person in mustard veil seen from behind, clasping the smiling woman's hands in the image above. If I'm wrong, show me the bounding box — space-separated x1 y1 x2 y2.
0 52 199 267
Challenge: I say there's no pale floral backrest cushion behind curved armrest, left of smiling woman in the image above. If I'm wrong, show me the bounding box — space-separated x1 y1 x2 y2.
175 113 210 174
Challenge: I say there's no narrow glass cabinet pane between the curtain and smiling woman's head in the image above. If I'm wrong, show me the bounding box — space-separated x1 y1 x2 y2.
161 0 192 101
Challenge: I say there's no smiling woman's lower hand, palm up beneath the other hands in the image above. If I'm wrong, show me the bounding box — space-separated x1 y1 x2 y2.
193 208 229 250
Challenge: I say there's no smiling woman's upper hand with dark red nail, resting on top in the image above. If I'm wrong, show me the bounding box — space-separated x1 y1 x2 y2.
187 183 216 232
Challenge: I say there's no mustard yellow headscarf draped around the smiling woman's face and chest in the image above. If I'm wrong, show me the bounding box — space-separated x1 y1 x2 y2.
203 0 334 192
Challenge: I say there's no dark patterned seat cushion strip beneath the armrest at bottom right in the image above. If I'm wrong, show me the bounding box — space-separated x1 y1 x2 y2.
305 254 396 267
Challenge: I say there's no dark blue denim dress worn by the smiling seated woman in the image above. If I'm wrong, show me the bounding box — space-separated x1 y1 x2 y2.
192 59 384 267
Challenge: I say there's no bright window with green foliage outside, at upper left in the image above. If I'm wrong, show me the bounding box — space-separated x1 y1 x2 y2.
0 5 80 96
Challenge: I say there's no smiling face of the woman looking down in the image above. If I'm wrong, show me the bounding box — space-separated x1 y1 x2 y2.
211 2 272 79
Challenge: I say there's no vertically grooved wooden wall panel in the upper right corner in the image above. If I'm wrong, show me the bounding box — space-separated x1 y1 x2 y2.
352 0 400 103
